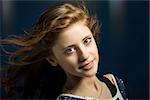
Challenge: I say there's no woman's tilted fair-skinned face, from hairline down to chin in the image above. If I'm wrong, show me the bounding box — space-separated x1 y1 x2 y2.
52 22 99 77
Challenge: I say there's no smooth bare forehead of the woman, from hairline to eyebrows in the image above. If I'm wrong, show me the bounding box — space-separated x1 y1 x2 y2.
53 23 92 47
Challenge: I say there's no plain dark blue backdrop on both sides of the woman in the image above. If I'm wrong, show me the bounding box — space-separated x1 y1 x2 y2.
0 0 149 99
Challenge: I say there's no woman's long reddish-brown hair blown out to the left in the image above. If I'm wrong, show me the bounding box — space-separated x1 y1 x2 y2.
1 4 100 98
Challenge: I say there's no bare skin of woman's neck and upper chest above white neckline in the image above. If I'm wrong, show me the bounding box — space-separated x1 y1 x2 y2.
64 76 112 99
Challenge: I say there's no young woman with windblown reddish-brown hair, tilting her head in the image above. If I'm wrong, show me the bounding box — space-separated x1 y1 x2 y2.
1 1 126 100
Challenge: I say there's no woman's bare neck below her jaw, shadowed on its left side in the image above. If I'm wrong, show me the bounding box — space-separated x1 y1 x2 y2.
64 75 101 97
